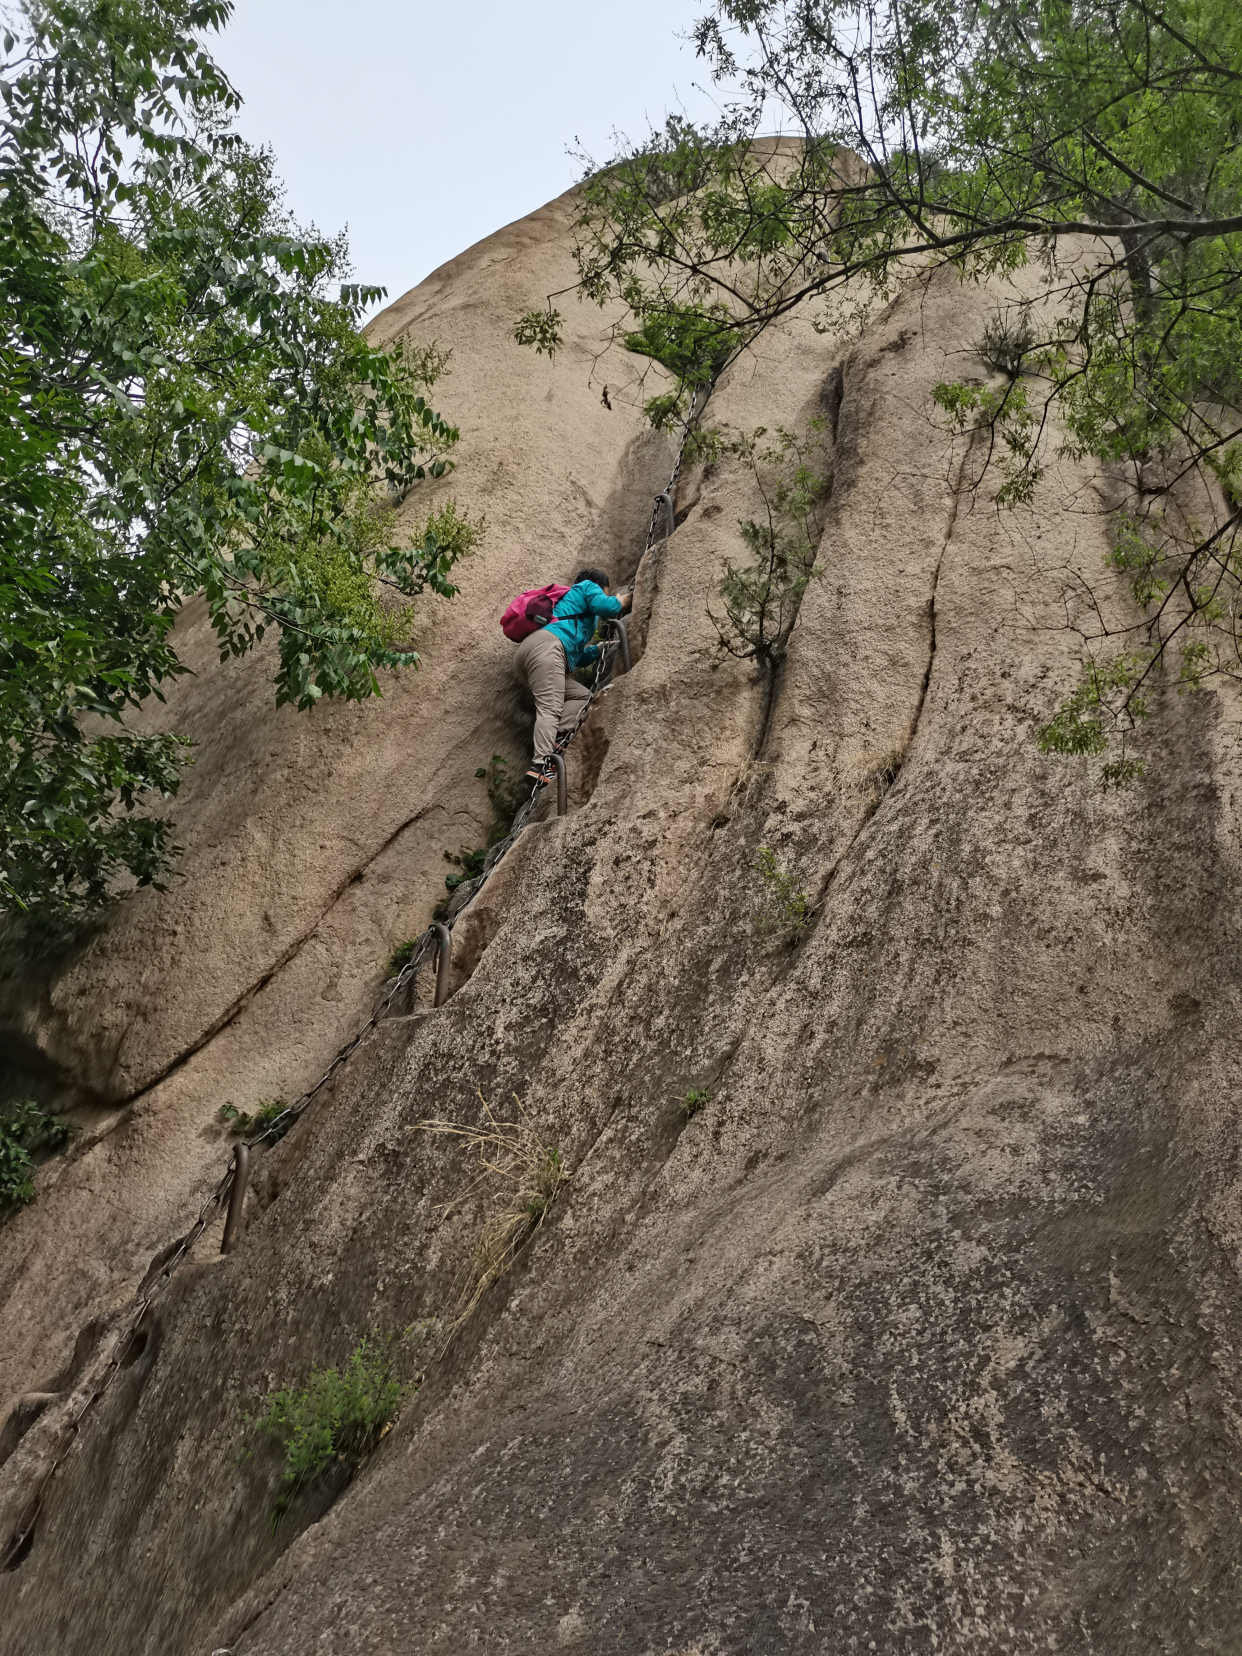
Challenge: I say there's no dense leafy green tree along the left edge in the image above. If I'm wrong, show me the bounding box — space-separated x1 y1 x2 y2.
0 0 479 922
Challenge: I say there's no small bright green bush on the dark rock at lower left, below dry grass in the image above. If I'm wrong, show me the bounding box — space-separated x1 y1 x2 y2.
247 1335 412 1525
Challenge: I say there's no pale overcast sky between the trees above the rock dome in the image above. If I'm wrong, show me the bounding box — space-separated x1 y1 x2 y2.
209 0 715 312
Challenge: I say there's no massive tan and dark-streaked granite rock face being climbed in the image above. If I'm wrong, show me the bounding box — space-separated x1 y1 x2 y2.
0 184 1242 1656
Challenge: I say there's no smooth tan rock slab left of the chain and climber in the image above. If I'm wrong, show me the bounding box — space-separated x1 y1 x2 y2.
0 190 671 1408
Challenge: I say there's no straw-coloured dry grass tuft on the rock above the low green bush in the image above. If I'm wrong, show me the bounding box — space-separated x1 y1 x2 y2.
411 1093 570 1355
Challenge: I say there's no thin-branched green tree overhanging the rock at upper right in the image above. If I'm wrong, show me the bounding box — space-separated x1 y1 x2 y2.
546 0 1242 780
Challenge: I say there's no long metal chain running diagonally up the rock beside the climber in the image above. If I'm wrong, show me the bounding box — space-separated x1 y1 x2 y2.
0 381 715 1570
